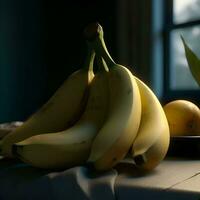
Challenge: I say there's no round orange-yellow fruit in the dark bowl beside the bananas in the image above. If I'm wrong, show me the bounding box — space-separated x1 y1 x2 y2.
163 100 200 136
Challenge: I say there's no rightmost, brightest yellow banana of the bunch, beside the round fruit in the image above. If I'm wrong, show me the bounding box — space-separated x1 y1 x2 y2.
131 77 170 170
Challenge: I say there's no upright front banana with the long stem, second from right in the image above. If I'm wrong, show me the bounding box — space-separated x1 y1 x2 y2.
85 23 141 170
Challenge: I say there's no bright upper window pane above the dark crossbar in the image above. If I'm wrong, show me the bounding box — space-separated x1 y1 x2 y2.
173 0 200 23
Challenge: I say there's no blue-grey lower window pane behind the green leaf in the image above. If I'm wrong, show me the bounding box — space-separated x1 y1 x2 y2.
170 26 200 89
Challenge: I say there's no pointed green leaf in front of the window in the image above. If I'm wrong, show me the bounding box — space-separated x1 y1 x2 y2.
181 36 200 86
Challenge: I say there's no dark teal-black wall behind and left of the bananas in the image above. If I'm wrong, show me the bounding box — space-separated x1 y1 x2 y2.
0 0 116 122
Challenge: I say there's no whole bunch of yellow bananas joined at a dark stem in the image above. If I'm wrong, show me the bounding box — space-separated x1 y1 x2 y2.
0 23 169 170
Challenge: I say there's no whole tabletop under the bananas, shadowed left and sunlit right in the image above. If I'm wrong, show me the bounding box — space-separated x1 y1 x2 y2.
0 158 200 200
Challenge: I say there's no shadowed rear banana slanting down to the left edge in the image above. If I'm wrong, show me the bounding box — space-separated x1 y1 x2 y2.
0 48 95 157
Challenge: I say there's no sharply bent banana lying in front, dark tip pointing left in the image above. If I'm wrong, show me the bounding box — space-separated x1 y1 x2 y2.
12 57 108 169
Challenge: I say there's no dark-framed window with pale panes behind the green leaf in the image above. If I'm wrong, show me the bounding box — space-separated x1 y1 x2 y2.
164 0 200 99
